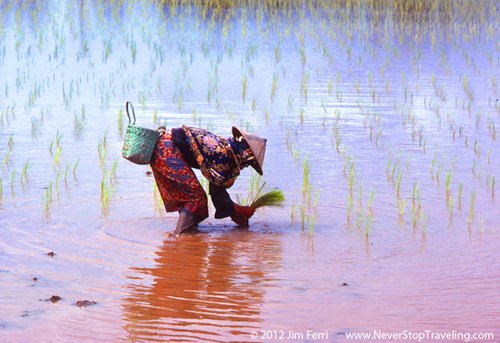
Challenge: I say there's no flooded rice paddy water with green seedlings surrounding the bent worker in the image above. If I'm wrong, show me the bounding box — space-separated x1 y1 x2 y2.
0 1 500 342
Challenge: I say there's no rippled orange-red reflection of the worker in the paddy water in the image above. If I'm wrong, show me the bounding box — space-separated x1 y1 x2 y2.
123 231 281 341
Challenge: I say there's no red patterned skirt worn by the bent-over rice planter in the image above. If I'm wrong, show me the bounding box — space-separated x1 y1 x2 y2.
151 130 208 221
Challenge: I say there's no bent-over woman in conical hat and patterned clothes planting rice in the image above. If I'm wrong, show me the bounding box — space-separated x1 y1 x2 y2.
151 126 266 235
